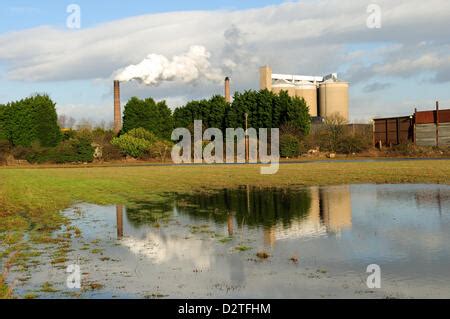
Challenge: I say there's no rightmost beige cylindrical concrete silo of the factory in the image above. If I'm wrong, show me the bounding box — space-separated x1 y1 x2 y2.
319 80 349 121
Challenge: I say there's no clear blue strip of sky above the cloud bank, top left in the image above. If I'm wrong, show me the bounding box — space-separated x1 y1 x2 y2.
0 0 284 32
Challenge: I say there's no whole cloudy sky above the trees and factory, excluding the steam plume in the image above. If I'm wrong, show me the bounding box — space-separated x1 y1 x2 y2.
0 0 450 123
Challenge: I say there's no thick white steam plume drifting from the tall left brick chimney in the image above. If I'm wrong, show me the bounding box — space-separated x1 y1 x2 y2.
115 45 224 86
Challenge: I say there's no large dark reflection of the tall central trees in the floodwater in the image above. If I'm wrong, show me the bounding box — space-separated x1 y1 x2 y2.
176 187 311 227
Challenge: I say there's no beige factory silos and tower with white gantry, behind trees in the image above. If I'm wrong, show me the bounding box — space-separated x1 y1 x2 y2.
260 66 349 121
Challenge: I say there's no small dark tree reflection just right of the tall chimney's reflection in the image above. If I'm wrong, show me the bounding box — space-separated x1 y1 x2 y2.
127 199 173 227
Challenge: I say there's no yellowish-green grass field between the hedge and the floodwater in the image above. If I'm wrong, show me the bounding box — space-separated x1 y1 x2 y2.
0 160 450 297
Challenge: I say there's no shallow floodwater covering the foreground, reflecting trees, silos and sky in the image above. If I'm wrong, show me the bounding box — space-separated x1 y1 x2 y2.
8 185 450 298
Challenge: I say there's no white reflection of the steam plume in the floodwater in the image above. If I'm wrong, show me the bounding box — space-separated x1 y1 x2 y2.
120 233 213 269
